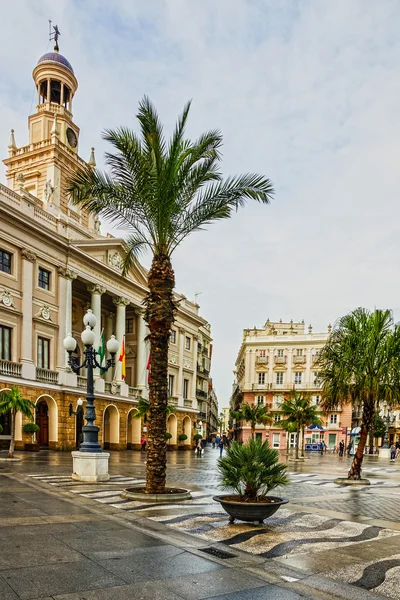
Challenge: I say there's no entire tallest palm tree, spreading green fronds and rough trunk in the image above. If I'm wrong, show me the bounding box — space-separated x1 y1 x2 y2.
69 97 273 493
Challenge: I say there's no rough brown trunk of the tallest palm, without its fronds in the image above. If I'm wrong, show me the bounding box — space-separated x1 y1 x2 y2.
145 254 175 494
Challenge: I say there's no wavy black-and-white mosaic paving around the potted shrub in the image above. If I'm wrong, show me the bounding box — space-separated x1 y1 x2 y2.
30 469 400 600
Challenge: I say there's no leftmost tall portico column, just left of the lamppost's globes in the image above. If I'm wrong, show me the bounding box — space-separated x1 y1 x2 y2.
56 267 78 386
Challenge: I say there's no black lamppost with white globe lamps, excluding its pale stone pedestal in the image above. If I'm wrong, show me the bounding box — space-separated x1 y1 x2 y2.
64 309 119 452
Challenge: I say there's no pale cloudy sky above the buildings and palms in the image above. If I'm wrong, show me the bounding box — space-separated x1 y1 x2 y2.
0 0 400 406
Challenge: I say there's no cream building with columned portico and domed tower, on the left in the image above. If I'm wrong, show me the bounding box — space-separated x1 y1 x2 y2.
0 44 211 449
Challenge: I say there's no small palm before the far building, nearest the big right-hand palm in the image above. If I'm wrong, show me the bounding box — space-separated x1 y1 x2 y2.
280 392 321 459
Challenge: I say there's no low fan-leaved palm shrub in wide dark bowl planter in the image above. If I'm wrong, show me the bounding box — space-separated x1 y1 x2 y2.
214 438 289 523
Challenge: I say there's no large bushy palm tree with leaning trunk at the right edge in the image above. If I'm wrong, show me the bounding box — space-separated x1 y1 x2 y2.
318 308 400 480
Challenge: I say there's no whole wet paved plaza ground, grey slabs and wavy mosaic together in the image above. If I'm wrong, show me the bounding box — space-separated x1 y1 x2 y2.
0 448 400 600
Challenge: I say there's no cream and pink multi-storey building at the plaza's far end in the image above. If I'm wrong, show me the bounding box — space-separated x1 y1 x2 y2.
231 320 352 450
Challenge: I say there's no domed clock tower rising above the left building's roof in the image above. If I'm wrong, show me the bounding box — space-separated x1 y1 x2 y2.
4 37 95 237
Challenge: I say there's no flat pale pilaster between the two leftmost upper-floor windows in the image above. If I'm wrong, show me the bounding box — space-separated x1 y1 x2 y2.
20 248 36 379
